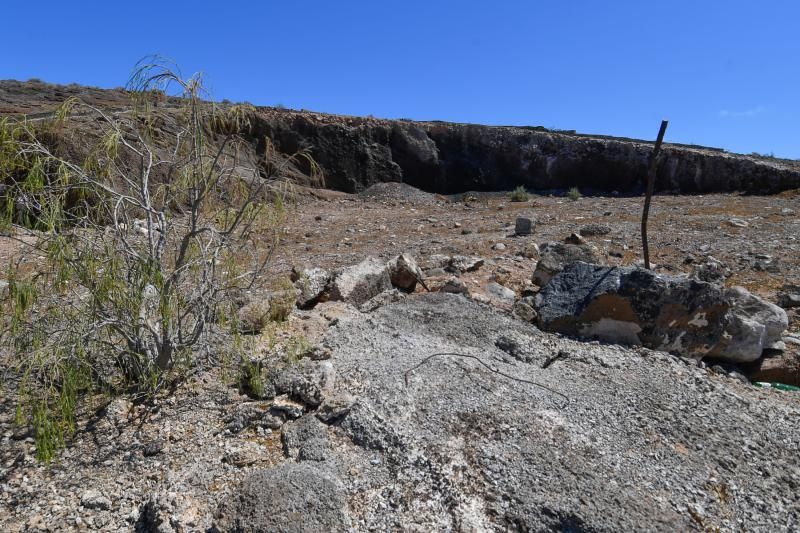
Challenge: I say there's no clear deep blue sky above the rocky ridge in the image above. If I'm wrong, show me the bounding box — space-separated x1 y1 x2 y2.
0 0 800 158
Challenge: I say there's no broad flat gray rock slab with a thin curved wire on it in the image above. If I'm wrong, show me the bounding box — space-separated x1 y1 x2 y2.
318 293 800 532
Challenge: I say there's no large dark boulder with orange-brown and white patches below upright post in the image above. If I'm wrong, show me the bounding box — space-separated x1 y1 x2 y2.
536 262 788 362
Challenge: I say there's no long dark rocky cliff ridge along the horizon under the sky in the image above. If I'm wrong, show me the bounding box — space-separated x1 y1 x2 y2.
6 81 800 193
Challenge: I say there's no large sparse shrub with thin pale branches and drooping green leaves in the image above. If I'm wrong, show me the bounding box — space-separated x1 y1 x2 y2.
0 60 318 461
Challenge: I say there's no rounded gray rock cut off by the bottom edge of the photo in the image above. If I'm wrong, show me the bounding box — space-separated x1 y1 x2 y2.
215 462 349 533
